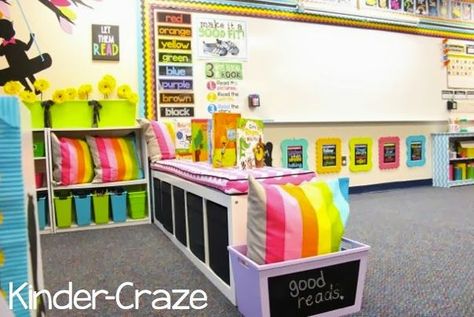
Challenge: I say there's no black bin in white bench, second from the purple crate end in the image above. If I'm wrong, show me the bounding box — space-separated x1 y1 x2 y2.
186 193 205 262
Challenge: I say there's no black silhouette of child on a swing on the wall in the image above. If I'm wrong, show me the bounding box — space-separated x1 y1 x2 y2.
0 19 52 91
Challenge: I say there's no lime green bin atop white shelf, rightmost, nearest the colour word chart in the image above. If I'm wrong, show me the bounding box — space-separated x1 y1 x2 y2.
98 99 137 128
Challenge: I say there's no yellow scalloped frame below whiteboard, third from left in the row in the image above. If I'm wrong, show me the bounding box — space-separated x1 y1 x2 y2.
349 138 372 172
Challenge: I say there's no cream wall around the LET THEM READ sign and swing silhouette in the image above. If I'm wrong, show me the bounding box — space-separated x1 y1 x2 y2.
0 0 139 99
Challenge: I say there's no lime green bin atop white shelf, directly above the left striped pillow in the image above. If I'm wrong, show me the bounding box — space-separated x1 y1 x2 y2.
50 100 94 129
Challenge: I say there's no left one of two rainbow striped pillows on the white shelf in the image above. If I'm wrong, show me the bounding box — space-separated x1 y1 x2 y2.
51 133 94 185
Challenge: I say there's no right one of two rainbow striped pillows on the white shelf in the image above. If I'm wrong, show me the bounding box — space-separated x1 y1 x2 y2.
86 135 143 183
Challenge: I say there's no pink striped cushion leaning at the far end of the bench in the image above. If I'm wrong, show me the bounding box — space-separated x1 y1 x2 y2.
139 119 176 162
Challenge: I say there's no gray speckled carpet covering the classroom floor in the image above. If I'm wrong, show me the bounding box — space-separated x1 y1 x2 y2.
42 186 474 317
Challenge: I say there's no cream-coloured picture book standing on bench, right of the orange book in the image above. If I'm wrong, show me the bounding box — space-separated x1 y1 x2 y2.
237 118 265 169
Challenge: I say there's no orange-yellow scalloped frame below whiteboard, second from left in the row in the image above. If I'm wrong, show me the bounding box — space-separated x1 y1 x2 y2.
316 138 342 174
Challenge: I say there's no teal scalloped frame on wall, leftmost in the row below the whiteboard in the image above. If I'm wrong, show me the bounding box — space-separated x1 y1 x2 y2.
280 139 308 170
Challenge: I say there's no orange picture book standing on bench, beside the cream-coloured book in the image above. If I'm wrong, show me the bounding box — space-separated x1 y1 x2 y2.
212 112 240 167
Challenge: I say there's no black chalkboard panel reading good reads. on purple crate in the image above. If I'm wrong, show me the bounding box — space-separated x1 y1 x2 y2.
268 260 360 317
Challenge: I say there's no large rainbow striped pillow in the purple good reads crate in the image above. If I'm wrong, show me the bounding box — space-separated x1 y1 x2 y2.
247 177 349 264
